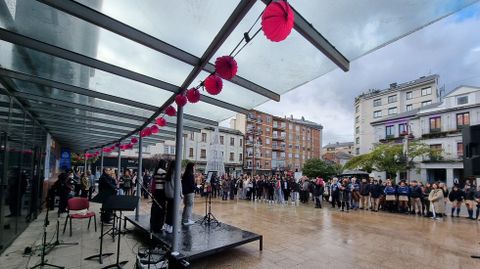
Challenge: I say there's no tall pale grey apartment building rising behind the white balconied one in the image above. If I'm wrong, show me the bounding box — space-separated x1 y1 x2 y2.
353 75 439 155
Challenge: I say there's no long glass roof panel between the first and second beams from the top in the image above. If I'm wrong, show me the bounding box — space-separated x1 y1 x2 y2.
2 0 192 84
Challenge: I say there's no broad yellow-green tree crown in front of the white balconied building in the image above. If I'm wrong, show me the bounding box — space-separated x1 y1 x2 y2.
345 141 442 175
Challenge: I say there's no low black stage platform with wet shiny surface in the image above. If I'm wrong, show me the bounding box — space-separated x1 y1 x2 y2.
126 215 263 261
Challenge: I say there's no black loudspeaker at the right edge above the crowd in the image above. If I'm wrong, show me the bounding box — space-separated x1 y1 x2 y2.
462 125 480 177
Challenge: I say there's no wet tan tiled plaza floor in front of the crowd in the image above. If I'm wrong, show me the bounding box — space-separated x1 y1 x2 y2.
0 196 480 269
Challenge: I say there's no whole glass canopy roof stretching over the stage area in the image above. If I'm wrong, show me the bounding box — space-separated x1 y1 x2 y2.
0 0 478 150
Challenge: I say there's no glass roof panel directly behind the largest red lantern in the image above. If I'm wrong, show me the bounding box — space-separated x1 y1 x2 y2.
211 1 335 93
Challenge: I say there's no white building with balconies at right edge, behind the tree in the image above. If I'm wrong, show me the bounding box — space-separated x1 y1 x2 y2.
372 86 480 187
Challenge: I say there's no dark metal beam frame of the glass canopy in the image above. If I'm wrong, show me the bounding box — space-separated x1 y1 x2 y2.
0 0 349 151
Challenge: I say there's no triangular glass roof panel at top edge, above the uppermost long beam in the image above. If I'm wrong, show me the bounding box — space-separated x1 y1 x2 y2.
77 0 239 57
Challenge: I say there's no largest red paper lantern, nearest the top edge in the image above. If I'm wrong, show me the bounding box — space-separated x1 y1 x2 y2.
262 0 295 42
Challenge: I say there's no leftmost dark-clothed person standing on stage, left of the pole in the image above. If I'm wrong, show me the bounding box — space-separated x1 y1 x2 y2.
150 160 167 233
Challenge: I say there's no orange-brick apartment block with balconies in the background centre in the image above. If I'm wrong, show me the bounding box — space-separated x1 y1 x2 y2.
230 110 323 174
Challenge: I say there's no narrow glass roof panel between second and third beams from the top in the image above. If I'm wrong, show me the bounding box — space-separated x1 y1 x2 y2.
0 41 172 106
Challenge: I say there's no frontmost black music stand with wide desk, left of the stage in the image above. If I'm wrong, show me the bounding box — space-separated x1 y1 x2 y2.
102 195 140 269
